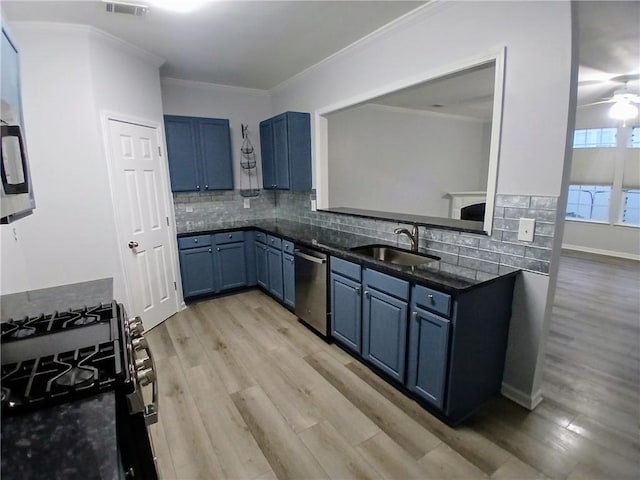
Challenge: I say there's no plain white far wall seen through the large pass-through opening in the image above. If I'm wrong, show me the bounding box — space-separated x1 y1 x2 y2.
328 105 489 217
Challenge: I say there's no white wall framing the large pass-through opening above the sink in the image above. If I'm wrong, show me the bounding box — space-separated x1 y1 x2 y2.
273 2 572 405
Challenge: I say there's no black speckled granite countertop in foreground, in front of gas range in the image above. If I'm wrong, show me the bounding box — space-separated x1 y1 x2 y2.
1 392 120 480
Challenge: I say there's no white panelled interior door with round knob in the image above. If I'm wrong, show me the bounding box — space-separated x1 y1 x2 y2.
108 119 178 329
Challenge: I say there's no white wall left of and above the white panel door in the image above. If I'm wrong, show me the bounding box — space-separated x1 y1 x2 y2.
0 22 168 306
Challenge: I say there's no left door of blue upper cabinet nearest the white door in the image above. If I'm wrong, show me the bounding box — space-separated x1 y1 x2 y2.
164 115 201 192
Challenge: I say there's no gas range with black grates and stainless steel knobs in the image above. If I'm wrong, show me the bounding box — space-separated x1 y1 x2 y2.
0 302 158 479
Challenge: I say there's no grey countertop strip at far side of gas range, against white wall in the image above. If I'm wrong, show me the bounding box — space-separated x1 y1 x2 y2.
0 278 113 322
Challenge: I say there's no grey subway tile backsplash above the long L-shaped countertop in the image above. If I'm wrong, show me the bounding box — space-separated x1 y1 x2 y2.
173 190 558 280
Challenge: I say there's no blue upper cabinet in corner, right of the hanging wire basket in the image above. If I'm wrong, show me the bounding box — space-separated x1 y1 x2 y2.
260 112 311 192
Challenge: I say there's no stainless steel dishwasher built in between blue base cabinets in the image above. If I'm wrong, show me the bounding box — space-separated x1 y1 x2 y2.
295 246 328 337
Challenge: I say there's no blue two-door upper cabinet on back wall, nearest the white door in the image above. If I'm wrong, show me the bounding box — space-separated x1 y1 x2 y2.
164 115 233 192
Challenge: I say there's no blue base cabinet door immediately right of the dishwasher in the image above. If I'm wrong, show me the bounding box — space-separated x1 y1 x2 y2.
331 273 362 353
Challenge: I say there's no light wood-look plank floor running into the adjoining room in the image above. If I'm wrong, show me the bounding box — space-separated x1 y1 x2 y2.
147 256 640 480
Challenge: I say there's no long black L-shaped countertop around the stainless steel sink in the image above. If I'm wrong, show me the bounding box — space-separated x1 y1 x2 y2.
178 219 517 295
